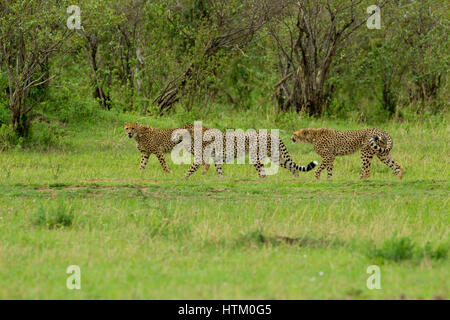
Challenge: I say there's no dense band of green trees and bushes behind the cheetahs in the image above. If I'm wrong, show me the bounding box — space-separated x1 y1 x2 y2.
0 0 450 143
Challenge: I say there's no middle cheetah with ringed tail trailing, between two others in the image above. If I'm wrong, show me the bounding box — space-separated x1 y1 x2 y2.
181 127 318 179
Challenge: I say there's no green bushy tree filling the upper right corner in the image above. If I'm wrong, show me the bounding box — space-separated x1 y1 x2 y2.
341 0 449 116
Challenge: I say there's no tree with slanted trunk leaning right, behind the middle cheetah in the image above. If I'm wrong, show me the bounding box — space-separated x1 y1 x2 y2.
153 0 286 112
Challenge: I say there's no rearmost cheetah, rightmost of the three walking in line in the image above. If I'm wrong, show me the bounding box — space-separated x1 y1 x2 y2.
292 128 403 179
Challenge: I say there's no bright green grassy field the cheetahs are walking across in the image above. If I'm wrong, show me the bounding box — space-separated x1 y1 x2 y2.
0 111 450 299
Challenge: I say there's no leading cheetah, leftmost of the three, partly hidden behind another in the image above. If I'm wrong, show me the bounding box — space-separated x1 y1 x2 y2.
124 122 209 173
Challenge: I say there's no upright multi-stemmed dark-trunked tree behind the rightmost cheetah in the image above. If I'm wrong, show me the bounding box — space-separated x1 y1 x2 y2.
269 0 387 116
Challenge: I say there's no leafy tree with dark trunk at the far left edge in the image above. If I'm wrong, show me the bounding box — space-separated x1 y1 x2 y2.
0 0 70 136
